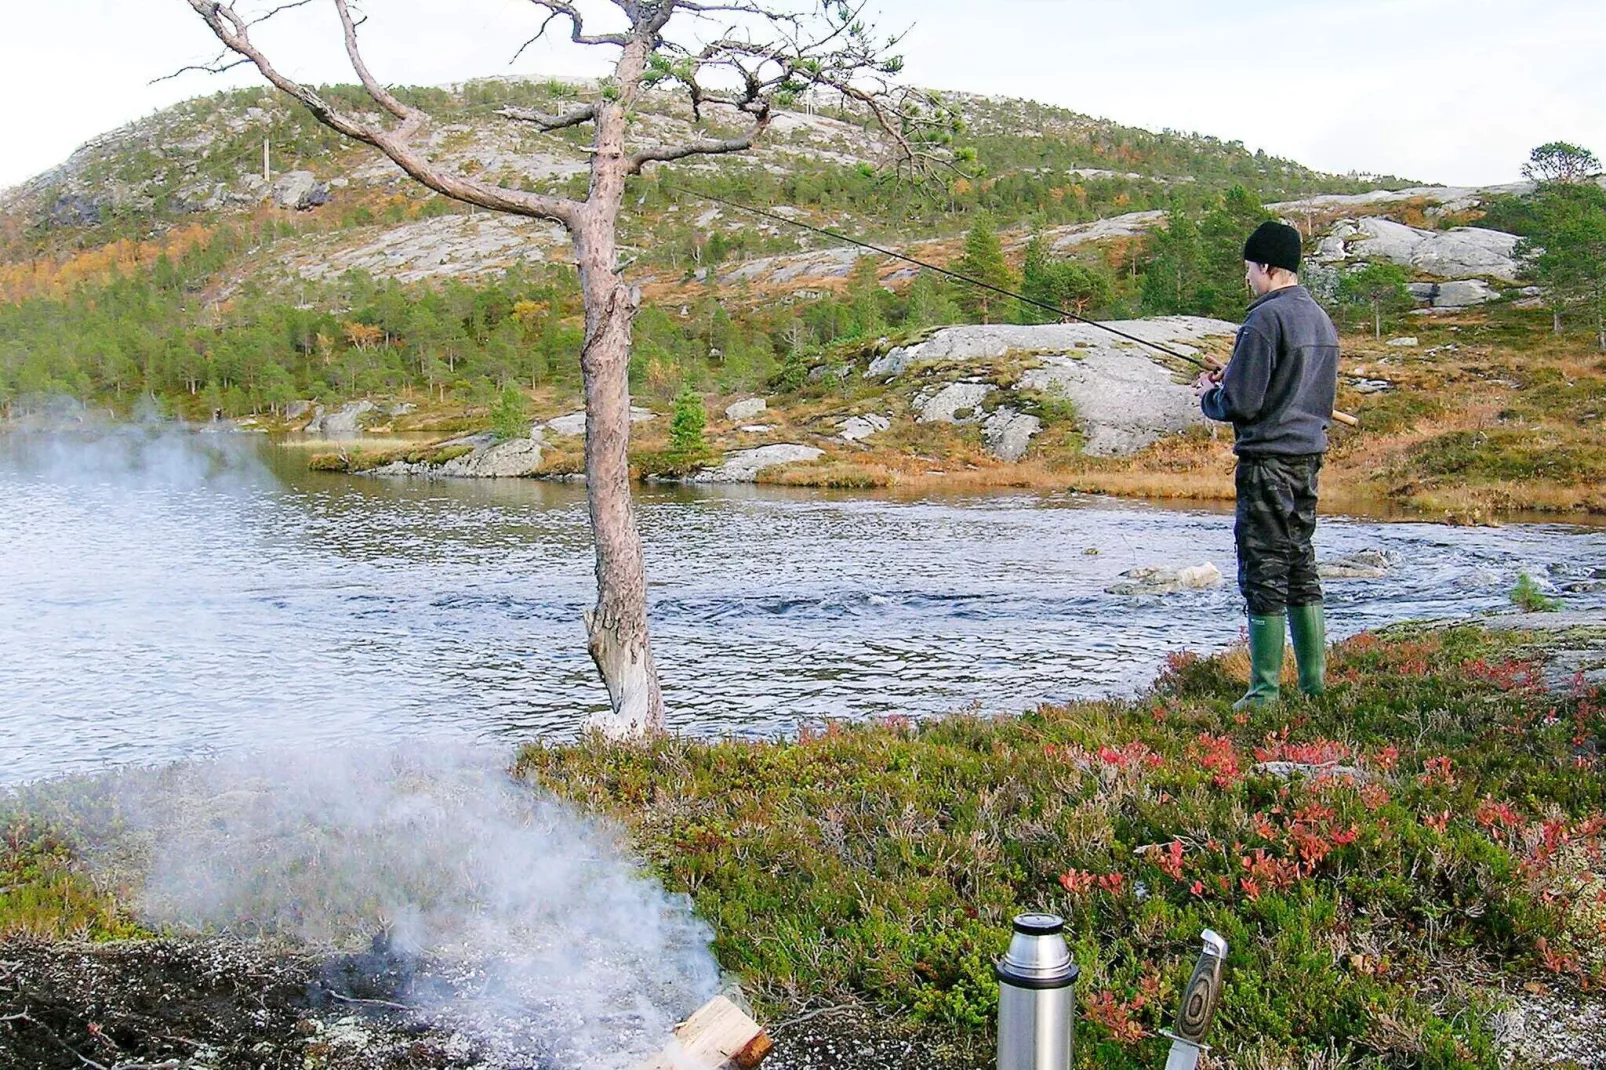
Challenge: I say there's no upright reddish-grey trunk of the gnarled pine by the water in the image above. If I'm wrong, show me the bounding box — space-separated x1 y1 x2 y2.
573 54 663 737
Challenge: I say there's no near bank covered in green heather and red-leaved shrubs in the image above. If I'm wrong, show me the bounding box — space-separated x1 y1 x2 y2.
0 615 1606 1068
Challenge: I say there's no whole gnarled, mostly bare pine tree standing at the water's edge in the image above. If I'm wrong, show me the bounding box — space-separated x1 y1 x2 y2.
179 0 954 737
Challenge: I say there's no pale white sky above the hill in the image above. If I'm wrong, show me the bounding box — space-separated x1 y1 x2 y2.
0 0 1606 186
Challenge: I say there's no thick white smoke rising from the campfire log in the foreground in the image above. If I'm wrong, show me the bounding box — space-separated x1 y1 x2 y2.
78 744 719 1068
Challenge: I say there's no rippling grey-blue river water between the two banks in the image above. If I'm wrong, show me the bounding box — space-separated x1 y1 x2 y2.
0 429 1606 784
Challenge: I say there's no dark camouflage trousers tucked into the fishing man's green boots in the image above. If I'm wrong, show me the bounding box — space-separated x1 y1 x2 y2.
1233 453 1322 617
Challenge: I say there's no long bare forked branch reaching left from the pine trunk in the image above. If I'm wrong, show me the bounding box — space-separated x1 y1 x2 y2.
190 0 581 230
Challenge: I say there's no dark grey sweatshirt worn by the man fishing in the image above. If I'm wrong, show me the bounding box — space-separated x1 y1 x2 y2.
1200 286 1338 456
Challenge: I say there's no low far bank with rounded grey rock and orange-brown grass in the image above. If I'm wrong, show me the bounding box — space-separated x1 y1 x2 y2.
265 305 1606 524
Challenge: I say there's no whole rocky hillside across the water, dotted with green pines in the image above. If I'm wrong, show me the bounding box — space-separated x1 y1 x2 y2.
0 73 1606 516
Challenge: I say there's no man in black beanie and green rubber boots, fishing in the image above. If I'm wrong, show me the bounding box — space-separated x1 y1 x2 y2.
1193 222 1338 710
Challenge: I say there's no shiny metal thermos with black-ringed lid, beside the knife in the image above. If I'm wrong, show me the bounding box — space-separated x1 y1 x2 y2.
994 914 1079 1070
